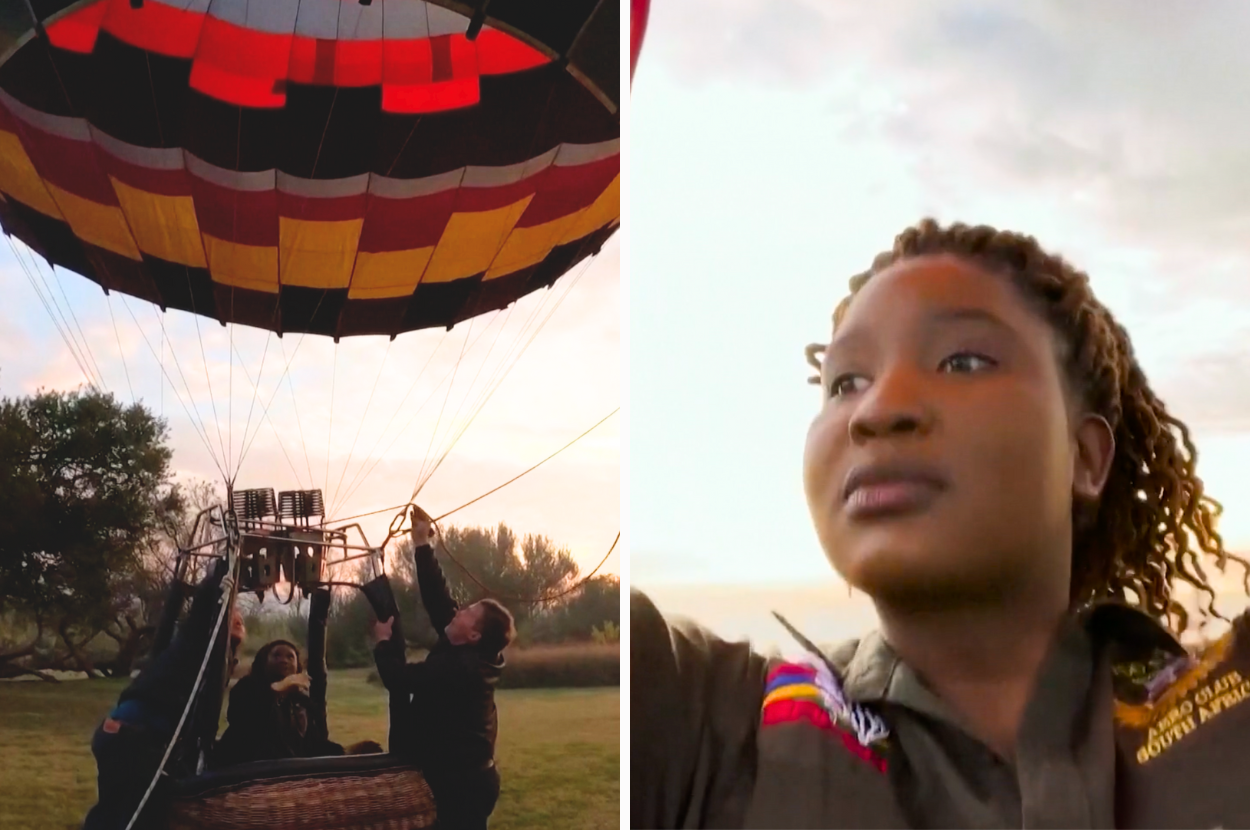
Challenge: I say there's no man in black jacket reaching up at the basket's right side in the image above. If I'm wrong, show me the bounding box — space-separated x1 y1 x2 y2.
374 510 516 830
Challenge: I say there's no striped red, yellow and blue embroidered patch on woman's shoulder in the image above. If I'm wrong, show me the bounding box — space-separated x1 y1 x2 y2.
760 655 890 773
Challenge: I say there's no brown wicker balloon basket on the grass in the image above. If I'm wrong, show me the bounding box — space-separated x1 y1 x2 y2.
166 755 436 830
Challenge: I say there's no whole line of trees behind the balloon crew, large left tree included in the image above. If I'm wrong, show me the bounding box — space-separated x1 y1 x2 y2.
0 390 620 679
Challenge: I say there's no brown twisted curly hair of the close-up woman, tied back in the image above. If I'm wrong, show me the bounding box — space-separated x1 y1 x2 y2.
806 219 1250 633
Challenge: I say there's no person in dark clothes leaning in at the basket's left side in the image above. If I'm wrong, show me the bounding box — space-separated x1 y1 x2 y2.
83 559 244 830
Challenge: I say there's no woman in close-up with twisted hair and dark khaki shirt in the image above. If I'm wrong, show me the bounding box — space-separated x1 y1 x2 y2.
630 220 1250 828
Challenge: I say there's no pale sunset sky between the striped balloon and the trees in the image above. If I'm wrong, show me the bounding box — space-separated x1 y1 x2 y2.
0 230 621 573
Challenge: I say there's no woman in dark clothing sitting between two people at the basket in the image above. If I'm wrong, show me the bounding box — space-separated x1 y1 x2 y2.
214 640 344 766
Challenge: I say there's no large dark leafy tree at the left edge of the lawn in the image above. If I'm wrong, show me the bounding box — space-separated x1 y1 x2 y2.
0 391 184 674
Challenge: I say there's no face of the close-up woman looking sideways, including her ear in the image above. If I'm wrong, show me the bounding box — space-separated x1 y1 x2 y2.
804 256 1114 606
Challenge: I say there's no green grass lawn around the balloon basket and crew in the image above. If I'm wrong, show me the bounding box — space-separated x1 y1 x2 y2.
0 669 620 830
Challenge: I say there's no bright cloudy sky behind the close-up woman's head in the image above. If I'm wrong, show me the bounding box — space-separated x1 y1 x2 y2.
629 0 1250 640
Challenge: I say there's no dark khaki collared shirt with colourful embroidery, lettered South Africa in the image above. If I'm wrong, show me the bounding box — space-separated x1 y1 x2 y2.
630 591 1250 828
